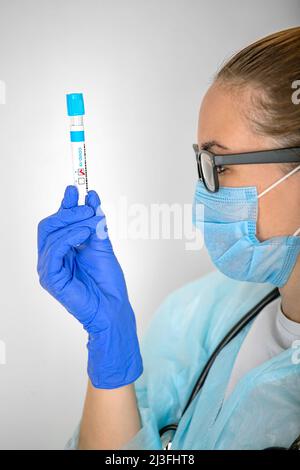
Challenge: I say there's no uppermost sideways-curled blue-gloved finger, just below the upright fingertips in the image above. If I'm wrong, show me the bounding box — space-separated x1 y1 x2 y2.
37 205 94 251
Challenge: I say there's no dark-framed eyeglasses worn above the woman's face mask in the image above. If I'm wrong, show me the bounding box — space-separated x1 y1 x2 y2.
193 144 300 193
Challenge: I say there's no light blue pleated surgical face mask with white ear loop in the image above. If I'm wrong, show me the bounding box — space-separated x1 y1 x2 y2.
192 165 300 287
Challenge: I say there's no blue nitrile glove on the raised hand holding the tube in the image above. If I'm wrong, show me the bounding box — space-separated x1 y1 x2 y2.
37 186 143 389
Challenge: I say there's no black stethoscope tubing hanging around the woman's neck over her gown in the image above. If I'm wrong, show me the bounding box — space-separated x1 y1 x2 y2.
159 287 300 450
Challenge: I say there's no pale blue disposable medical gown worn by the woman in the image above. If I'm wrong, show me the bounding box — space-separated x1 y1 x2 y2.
65 271 300 450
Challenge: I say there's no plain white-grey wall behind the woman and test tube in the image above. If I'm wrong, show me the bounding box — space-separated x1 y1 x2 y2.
0 0 300 449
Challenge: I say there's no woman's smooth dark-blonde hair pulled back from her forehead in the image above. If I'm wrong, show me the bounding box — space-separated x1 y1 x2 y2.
213 26 300 162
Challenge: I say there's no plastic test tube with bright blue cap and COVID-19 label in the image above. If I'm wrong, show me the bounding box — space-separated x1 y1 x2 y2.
66 93 88 205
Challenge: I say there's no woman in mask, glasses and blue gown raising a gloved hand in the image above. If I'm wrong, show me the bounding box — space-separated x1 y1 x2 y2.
38 27 300 449
